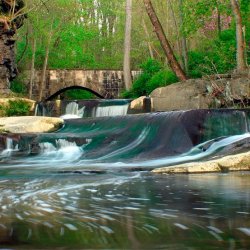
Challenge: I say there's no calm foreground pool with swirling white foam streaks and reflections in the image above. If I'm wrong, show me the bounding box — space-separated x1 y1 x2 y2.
0 171 250 249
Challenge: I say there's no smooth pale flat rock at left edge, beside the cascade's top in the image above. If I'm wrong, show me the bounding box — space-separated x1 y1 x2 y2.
0 116 64 133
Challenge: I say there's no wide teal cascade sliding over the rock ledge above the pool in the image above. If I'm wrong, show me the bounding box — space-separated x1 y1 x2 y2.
0 109 249 169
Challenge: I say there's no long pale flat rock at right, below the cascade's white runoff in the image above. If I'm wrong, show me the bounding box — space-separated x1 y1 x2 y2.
152 152 250 174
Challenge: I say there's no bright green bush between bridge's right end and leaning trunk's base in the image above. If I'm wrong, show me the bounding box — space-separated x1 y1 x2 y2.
123 59 178 98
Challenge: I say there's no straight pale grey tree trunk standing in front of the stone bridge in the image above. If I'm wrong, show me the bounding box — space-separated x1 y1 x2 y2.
123 0 132 90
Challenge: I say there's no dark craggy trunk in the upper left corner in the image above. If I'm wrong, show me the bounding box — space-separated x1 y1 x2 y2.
0 0 26 94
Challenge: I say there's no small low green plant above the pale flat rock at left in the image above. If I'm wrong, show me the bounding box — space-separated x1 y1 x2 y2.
4 100 31 116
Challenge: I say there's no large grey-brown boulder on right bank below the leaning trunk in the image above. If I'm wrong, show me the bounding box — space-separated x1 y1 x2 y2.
150 76 250 111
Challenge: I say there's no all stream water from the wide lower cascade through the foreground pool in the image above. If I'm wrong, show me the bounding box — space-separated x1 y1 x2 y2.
0 109 250 249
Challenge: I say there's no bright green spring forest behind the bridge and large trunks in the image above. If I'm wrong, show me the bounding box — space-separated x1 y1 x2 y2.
12 0 250 97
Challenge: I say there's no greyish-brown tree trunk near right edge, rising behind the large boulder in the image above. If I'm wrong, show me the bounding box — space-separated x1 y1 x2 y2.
231 0 247 71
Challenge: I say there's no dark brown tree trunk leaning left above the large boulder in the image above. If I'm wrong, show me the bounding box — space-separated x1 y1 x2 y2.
144 0 187 81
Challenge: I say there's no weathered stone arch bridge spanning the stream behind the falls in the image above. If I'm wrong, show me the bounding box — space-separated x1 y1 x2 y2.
25 69 140 100
